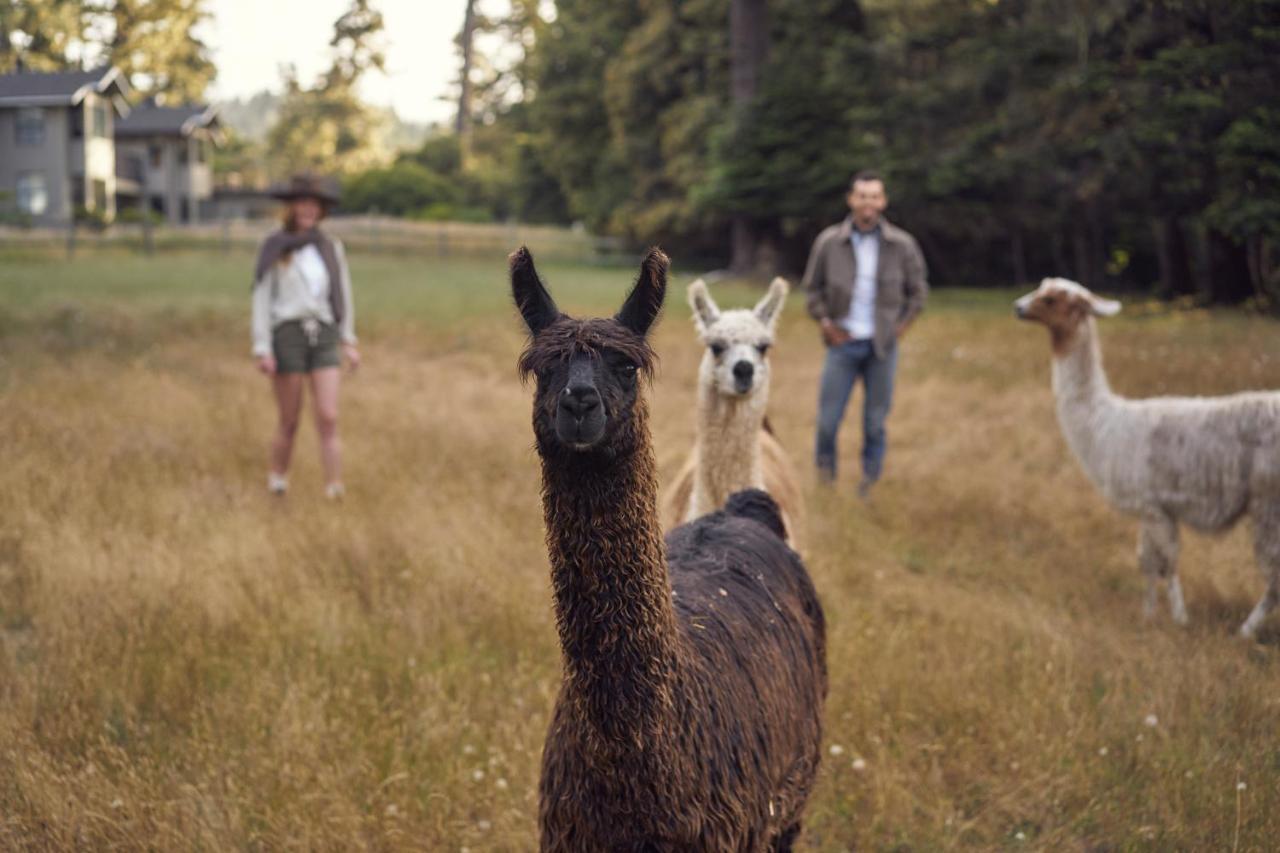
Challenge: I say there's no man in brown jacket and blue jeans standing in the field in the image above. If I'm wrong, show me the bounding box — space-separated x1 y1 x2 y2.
804 172 929 497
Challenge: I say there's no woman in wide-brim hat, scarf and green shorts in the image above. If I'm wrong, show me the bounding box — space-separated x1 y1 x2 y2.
253 174 360 498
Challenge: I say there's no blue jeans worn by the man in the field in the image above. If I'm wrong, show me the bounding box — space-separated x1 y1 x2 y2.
814 341 897 480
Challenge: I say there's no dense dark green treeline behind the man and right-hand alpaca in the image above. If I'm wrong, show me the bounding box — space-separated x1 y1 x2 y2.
335 0 1280 305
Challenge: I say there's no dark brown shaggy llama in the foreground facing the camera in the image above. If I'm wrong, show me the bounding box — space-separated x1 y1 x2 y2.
511 248 827 853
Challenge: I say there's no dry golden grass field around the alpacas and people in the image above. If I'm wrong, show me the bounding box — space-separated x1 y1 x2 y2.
0 246 1280 850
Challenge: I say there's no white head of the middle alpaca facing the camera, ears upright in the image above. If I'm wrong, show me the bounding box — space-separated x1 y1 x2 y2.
689 278 787 400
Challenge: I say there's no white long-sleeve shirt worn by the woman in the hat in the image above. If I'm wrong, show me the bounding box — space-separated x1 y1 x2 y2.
252 240 356 356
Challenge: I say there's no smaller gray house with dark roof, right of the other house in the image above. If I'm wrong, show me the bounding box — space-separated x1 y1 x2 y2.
115 102 221 224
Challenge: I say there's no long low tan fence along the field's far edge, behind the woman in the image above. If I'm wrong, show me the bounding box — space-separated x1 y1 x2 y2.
0 216 635 264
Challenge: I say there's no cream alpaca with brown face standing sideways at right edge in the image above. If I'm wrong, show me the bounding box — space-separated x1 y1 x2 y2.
1015 278 1280 637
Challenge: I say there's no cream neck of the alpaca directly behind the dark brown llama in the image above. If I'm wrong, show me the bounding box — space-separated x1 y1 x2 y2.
690 382 768 517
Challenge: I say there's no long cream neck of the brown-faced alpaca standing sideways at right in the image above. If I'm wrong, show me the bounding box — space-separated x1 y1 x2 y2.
1053 316 1119 483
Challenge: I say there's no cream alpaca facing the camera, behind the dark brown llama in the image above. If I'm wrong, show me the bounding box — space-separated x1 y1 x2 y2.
667 278 804 549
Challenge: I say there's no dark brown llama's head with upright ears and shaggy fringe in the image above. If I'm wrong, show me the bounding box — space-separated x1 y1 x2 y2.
511 248 669 456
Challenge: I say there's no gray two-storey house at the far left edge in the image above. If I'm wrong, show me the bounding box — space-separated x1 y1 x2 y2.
0 68 129 224
